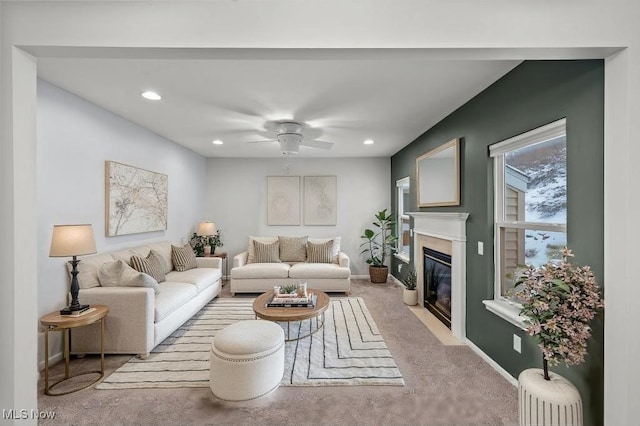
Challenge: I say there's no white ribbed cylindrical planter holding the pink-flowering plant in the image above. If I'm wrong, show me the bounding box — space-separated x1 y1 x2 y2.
518 368 583 426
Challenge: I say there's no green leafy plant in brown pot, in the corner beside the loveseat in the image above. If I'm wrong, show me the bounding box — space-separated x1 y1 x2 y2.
360 209 398 283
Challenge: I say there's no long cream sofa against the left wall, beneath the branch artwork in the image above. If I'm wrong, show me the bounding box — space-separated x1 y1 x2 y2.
71 241 222 357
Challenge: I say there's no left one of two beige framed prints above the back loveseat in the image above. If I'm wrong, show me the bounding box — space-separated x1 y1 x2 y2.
267 176 300 225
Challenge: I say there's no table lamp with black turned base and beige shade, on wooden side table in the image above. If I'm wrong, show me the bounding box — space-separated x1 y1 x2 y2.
49 225 96 315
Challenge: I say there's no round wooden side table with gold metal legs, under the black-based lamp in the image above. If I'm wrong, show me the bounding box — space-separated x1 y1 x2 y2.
40 305 109 395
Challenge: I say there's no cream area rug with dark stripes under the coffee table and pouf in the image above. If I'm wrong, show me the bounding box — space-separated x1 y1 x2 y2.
96 297 404 389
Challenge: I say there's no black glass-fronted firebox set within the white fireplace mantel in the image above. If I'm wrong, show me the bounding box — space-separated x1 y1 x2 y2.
422 247 451 328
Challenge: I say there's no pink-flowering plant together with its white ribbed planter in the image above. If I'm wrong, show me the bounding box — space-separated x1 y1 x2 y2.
518 247 603 422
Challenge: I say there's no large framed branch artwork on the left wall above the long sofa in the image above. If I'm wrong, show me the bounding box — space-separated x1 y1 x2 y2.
105 161 169 237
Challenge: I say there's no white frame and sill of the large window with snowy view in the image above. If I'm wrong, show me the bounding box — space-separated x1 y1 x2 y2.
483 118 568 329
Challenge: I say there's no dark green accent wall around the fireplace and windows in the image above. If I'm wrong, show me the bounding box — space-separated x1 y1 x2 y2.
391 60 604 425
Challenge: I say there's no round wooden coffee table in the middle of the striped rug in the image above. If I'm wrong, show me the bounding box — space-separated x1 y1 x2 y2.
253 289 329 342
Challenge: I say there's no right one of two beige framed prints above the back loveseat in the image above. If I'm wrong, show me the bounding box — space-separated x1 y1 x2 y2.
304 176 338 225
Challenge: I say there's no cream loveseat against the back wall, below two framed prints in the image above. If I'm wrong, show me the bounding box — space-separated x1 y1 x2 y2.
229 237 351 295
